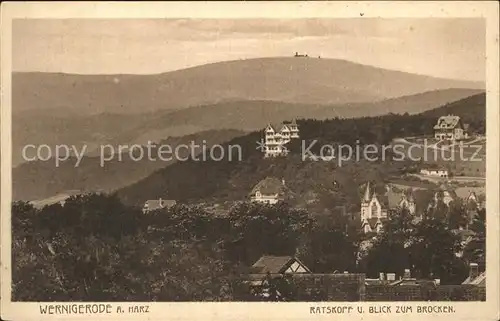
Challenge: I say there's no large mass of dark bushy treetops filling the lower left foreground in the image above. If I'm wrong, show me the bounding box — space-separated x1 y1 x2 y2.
12 194 358 301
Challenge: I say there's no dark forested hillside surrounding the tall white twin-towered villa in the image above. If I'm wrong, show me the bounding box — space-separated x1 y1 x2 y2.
117 95 484 205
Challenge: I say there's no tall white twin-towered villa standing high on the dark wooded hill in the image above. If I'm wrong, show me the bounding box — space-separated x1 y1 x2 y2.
264 119 299 157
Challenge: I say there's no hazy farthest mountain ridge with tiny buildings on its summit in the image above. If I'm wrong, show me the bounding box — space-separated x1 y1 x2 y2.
12 57 484 114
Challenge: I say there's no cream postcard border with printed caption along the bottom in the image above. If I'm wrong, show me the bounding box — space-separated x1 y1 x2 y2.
0 1 500 321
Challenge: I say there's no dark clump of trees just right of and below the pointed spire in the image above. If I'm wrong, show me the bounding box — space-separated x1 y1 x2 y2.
361 207 467 284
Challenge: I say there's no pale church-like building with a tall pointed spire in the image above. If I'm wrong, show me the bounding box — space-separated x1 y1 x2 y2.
361 182 387 233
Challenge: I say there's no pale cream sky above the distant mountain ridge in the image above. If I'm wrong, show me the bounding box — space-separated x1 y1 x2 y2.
12 18 486 81
